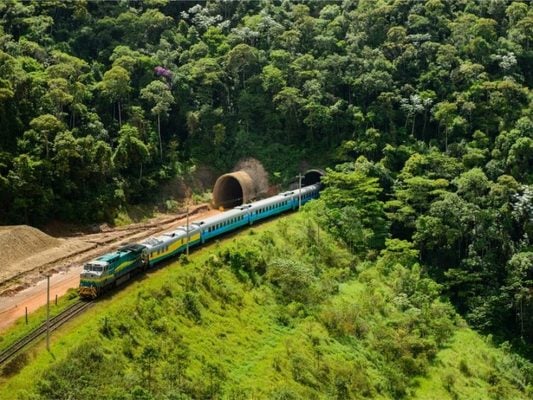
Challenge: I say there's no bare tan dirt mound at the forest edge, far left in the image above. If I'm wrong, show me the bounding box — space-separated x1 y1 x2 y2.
0 225 61 268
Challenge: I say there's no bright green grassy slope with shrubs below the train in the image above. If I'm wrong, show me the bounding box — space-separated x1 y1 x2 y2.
0 212 531 399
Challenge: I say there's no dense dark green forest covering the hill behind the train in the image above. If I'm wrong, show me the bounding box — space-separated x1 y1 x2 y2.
0 0 533 394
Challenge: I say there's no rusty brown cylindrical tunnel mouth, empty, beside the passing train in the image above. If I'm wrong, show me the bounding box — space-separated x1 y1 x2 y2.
213 171 255 209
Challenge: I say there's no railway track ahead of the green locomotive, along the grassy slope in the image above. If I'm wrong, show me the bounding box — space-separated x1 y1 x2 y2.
0 301 93 365
